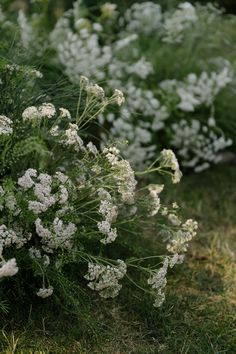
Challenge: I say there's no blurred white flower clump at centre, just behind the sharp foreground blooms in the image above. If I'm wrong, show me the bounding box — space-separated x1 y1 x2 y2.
100 81 169 168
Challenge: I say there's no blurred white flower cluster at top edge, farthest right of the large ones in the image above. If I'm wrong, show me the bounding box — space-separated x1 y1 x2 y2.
162 2 198 43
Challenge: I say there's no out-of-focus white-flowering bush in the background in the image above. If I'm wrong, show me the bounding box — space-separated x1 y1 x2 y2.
5 1 234 172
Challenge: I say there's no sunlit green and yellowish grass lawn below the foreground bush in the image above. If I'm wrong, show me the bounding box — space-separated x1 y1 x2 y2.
0 165 236 354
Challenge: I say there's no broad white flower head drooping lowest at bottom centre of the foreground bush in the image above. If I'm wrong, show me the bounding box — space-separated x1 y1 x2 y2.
85 259 127 298
